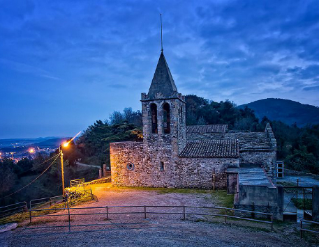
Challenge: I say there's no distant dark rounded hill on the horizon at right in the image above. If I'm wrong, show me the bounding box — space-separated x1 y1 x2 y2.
238 98 319 127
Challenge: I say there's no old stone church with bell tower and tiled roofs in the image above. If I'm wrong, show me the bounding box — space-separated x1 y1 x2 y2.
110 51 276 193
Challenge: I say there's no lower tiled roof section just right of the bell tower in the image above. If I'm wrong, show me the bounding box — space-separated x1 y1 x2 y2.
180 139 239 158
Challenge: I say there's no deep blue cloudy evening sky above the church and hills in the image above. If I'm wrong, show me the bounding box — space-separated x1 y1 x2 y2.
0 0 319 138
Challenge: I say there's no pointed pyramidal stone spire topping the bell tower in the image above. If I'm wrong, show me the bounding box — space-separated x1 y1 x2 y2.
148 52 177 99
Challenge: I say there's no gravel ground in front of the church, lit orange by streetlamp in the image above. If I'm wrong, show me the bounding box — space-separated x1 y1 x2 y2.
0 184 308 247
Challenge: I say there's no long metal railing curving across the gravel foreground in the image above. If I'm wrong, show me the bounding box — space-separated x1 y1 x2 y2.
27 203 273 231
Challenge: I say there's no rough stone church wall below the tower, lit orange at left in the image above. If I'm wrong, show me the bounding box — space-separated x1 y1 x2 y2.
110 142 239 189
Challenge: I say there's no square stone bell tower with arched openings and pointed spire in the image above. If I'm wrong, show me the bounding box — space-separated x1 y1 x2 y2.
141 51 186 155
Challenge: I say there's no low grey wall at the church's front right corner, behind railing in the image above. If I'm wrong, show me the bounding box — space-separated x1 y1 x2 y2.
234 185 284 220
